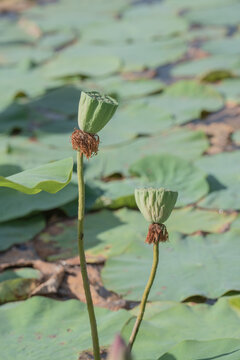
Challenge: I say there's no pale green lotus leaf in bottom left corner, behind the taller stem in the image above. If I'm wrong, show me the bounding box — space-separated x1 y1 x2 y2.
0 296 129 360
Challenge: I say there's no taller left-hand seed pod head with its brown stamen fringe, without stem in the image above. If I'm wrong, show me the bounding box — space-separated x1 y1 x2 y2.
71 91 118 159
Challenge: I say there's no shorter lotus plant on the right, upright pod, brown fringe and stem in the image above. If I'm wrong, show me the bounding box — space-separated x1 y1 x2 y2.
128 188 178 351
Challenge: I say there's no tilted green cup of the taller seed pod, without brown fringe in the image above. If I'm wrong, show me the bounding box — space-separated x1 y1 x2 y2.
78 91 118 134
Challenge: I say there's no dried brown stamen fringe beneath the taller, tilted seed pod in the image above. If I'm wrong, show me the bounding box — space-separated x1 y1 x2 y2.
71 129 99 159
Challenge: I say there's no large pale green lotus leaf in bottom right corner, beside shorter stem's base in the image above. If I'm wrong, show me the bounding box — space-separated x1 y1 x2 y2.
124 296 240 360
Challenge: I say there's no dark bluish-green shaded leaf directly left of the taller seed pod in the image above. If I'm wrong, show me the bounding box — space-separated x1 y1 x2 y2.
0 85 81 136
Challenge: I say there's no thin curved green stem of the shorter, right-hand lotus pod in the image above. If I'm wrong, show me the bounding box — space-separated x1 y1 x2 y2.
128 242 159 351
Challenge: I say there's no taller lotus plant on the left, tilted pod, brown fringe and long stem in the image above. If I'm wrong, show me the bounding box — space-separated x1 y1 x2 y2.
71 91 118 360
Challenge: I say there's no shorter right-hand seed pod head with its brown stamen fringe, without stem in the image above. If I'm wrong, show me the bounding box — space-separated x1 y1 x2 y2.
135 188 178 244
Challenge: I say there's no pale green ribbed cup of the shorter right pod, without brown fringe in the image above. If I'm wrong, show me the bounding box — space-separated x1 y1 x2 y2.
135 188 178 224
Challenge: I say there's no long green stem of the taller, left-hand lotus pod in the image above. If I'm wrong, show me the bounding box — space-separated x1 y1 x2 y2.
77 151 100 360
